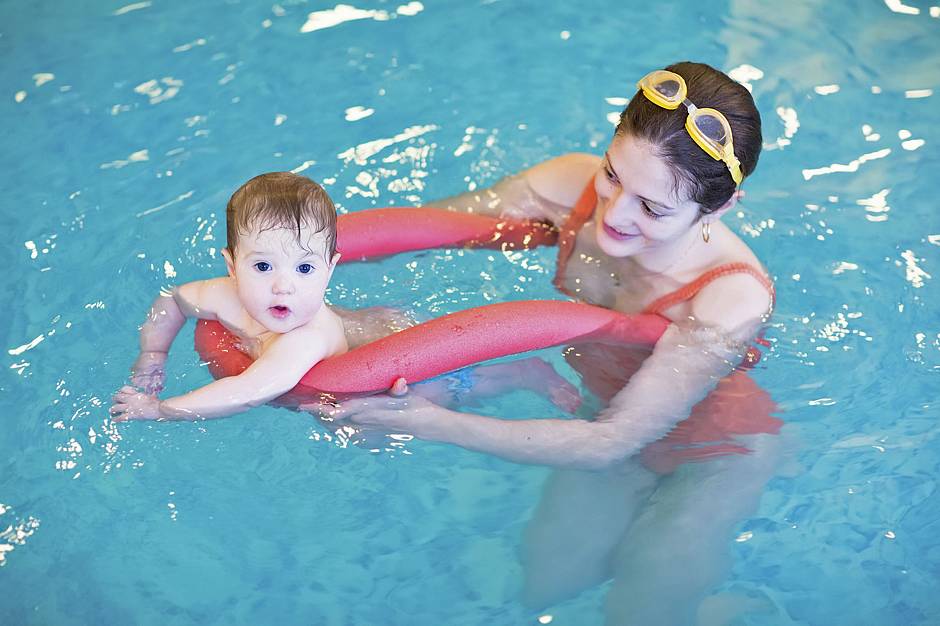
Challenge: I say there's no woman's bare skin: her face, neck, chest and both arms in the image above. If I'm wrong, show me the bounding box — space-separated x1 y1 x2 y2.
335 135 772 469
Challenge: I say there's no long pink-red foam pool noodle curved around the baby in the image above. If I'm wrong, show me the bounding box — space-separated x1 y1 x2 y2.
196 209 669 405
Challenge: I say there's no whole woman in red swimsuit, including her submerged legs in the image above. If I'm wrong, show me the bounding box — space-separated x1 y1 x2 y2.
338 63 780 623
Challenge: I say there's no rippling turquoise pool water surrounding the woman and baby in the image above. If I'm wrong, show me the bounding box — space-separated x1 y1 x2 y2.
0 0 940 625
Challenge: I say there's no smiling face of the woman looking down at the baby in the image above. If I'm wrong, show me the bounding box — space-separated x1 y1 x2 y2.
594 135 699 257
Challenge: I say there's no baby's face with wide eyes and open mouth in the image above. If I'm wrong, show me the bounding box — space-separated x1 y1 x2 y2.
228 226 338 333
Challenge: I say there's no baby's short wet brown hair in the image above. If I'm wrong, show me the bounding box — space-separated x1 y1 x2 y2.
225 172 336 261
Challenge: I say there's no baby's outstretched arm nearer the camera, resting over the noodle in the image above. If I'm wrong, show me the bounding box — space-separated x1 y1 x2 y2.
111 329 337 421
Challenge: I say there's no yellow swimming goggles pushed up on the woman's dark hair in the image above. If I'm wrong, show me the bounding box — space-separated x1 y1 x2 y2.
636 70 744 185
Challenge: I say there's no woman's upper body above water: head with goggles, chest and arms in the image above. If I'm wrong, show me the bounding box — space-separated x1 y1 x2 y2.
341 63 774 468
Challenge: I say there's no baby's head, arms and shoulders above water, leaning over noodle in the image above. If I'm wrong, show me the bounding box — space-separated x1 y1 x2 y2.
111 172 347 421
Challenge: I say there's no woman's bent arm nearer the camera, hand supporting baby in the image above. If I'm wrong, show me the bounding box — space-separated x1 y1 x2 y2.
338 324 741 469
